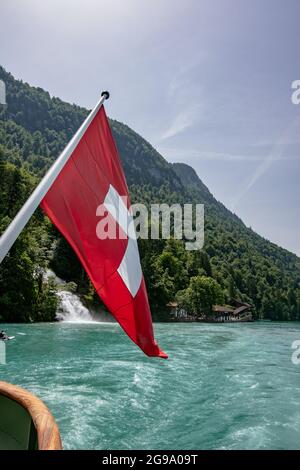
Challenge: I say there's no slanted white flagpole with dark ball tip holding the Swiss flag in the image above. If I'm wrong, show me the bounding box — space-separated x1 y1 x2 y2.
0 91 109 263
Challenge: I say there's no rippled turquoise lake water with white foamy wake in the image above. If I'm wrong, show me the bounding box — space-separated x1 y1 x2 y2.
0 322 300 449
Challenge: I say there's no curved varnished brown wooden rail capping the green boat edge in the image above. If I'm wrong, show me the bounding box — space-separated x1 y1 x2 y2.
0 381 62 450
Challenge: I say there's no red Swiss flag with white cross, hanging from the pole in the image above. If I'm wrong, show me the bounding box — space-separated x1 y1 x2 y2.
41 106 167 358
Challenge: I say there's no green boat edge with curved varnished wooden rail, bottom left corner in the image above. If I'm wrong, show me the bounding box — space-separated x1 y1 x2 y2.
0 381 62 450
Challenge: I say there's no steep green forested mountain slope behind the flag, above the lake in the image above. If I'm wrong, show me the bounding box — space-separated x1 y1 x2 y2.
0 67 300 321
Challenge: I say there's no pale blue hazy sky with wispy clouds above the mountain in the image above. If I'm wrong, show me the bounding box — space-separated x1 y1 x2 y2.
0 0 300 255
